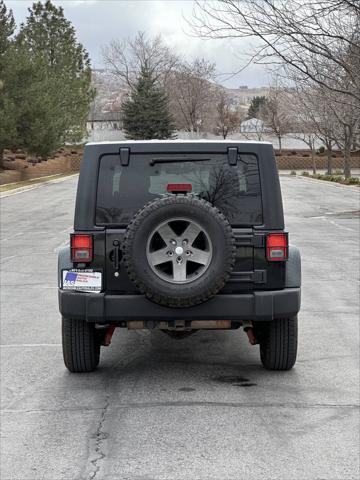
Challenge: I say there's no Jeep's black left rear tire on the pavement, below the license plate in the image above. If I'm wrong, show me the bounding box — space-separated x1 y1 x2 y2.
62 317 100 373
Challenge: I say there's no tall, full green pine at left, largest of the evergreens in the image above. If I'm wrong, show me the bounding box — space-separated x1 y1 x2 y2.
15 0 94 156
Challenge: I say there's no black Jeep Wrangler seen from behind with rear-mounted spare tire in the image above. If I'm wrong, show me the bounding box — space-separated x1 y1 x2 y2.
59 141 301 372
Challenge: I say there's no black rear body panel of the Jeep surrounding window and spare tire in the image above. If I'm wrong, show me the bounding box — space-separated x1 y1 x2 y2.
70 141 286 300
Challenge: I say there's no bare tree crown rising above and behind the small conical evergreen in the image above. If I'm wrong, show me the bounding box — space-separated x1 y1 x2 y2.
102 32 179 89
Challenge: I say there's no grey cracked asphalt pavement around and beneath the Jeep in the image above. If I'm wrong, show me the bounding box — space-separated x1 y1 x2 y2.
0 176 360 480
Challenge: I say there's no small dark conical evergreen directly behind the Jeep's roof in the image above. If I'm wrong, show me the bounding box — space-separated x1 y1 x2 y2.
122 68 175 140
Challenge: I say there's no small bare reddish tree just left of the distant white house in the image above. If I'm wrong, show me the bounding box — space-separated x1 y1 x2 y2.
214 88 245 140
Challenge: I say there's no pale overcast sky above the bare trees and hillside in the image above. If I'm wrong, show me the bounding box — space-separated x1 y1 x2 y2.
5 0 269 88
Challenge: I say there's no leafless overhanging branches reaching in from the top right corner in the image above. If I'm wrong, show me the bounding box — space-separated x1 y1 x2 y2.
190 0 360 105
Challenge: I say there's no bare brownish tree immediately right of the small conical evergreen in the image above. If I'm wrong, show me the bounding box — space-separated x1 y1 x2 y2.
167 58 215 133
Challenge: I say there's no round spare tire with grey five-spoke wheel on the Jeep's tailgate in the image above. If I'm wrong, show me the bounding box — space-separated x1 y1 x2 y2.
124 195 235 307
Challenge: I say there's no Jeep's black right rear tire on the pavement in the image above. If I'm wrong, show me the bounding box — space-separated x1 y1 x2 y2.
259 316 298 370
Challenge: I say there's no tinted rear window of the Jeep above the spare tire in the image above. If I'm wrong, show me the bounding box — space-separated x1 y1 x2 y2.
96 154 263 226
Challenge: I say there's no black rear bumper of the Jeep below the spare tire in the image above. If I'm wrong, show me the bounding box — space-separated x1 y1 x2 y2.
59 288 301 324
